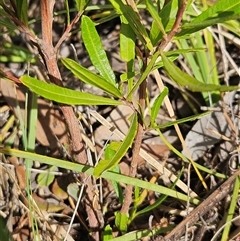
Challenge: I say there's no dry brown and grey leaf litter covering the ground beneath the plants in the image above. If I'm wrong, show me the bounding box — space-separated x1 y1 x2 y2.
0 0 239 240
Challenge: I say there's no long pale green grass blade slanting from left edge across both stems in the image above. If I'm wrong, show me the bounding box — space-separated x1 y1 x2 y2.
0 147 200 205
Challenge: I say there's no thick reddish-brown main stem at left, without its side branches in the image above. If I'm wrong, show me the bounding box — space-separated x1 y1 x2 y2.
40 0 102 240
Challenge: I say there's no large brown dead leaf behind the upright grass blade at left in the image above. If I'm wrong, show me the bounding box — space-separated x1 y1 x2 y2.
0 79 69 150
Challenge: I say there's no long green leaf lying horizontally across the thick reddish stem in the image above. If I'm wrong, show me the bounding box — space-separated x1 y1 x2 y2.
20 75 121 105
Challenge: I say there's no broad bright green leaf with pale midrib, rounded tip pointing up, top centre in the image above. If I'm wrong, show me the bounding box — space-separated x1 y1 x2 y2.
81 16 117 86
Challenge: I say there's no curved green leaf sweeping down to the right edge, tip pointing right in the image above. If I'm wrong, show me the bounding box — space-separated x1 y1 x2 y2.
161 53 239 92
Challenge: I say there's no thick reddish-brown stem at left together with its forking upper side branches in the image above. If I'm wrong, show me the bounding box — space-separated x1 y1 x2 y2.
1 0 103 241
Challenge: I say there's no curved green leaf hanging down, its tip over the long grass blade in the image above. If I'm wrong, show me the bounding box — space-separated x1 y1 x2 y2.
93 114 137 177
